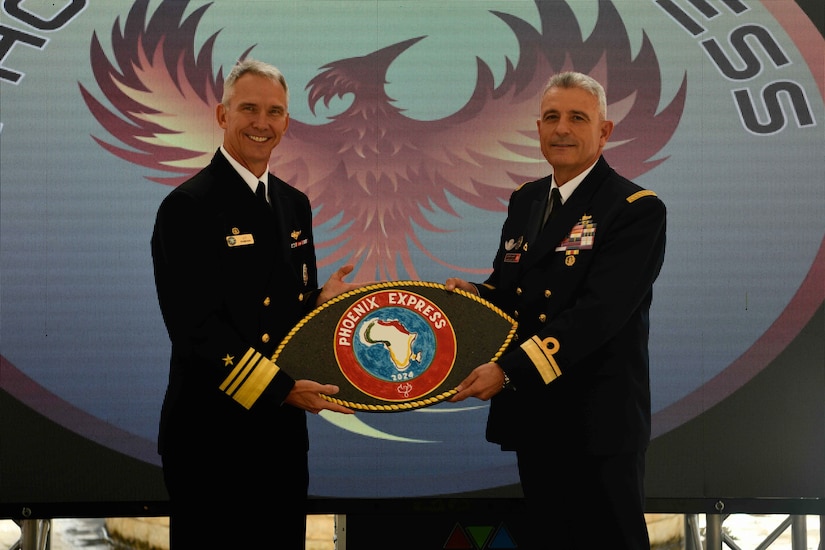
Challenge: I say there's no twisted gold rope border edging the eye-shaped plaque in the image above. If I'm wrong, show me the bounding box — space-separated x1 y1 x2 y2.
272 281 518 412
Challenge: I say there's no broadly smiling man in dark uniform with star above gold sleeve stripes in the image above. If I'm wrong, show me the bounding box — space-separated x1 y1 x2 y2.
152 59 359 550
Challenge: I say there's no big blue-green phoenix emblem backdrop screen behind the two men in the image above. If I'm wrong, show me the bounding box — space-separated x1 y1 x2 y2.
0 0 825 506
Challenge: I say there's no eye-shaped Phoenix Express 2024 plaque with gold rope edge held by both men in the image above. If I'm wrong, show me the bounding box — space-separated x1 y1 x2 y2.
272 281 517 412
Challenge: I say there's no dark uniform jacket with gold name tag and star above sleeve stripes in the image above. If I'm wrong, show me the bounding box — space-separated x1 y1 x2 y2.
152 151 318 458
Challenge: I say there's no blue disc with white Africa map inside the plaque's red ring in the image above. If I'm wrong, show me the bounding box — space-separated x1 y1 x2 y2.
352 307 436 382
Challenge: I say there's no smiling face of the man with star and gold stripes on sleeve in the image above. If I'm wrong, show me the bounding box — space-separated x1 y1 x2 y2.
216 73 289 176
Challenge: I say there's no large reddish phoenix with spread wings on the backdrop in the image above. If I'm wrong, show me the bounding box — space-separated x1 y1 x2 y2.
80 0 687 279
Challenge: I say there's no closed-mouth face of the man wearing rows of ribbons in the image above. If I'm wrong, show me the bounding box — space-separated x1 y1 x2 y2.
536 87 613 185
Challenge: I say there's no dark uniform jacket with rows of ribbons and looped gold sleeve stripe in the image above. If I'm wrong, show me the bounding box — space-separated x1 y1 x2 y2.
478 158 666 454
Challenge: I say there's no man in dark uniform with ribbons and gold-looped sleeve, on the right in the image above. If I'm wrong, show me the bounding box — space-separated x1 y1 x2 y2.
446 72 666 550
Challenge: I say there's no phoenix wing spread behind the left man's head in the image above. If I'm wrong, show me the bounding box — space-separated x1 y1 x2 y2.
80 0 223 185
